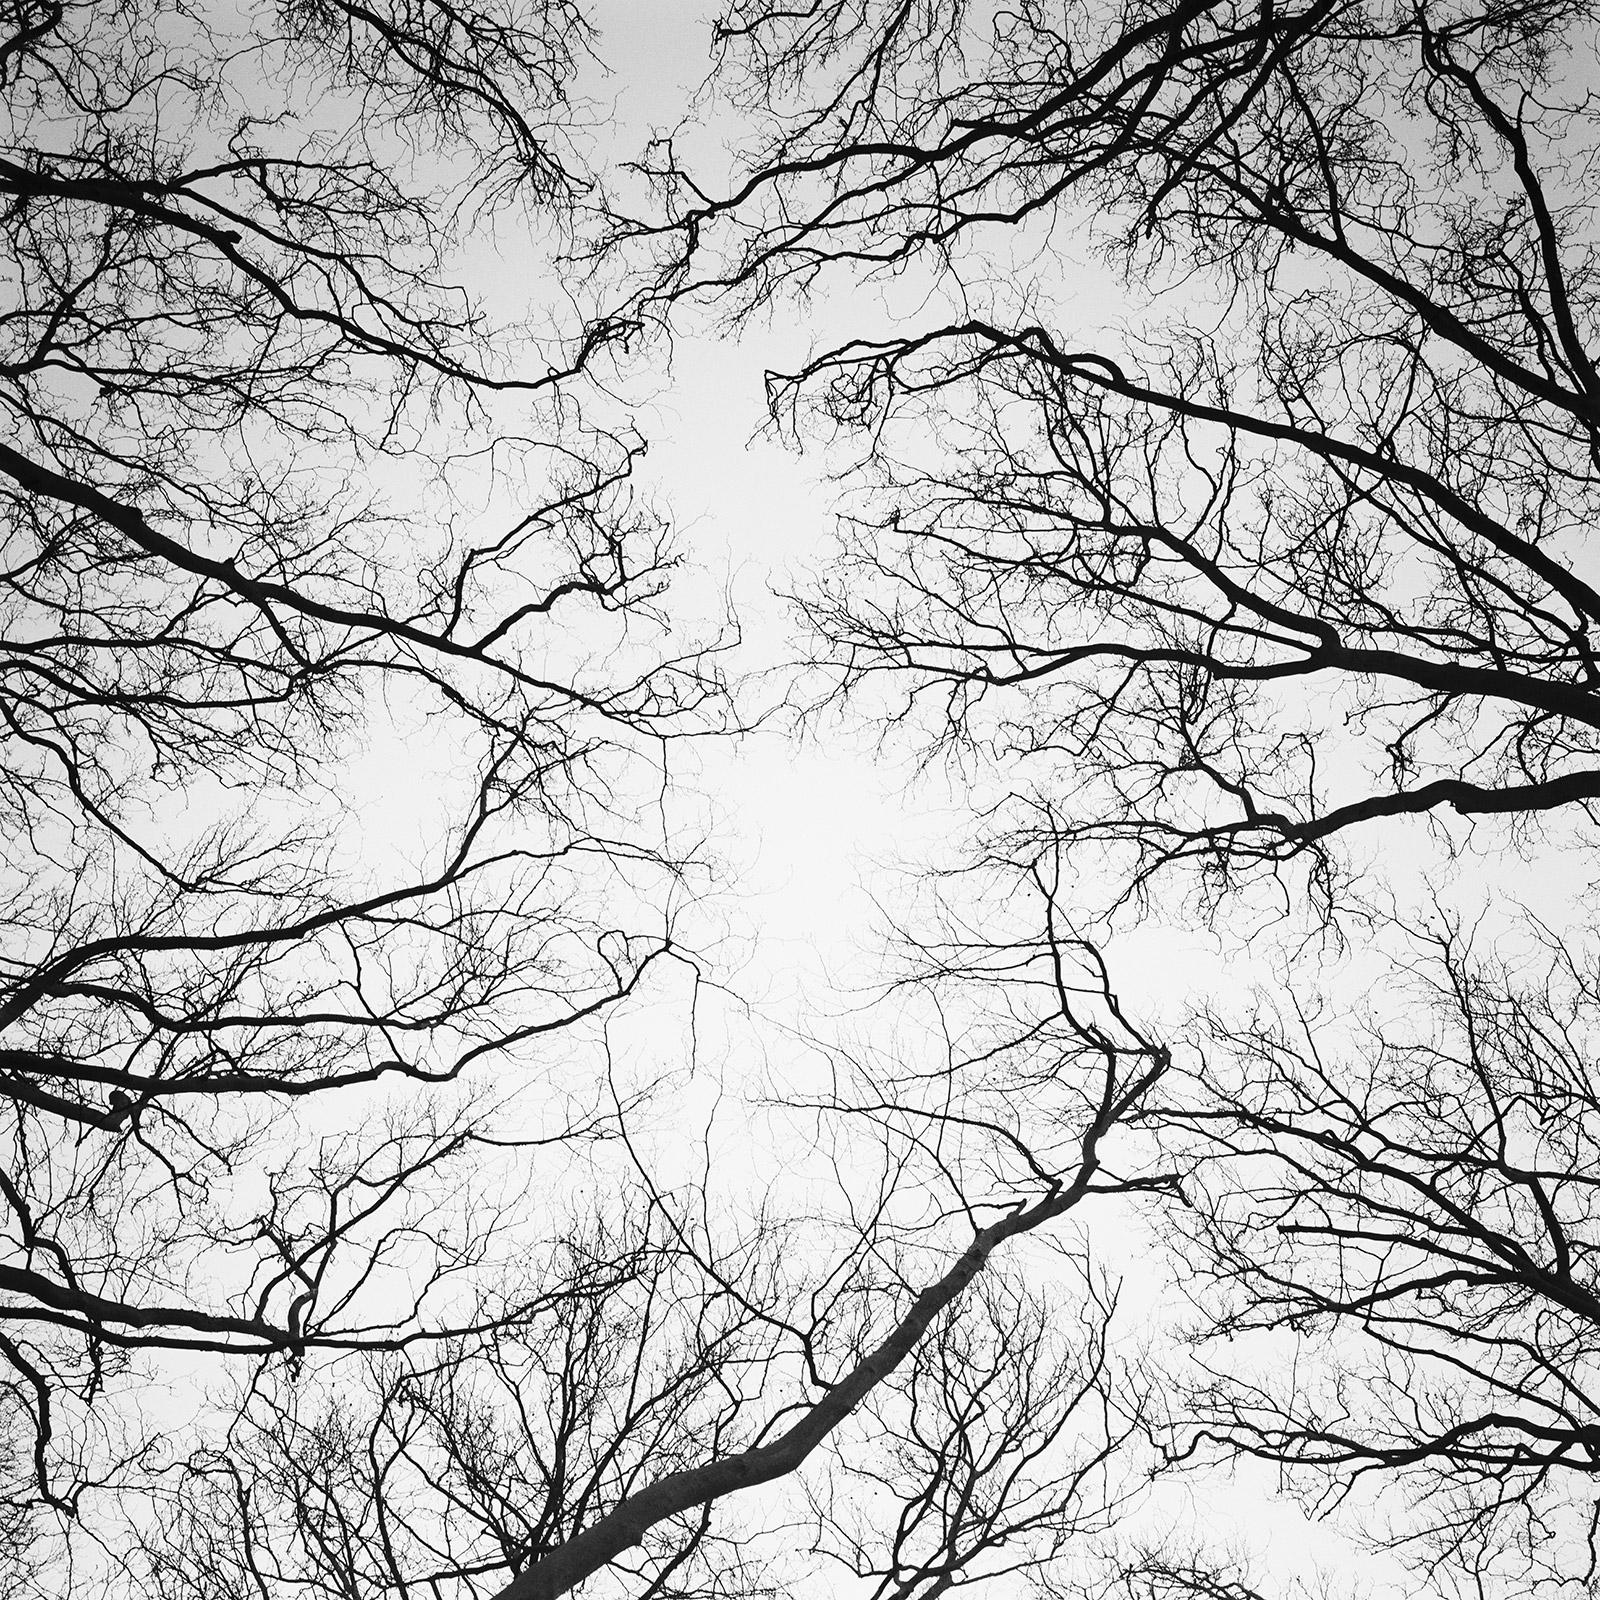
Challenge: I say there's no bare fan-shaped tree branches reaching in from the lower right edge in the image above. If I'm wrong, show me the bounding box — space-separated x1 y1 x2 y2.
1152 922 1600 1592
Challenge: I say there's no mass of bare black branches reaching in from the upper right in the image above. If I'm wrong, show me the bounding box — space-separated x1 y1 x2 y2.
619 3 1600 915
